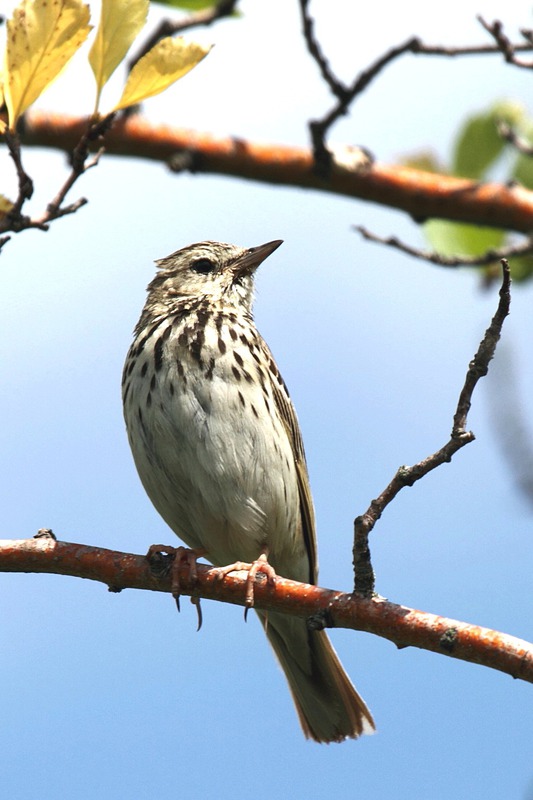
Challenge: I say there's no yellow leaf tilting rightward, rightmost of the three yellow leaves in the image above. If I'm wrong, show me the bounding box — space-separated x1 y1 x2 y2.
113 36 211 111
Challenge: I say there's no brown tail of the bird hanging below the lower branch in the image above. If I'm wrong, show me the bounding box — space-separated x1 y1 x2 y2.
258 612 375 742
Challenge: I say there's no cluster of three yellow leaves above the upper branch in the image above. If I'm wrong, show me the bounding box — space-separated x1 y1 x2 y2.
2 0 210 131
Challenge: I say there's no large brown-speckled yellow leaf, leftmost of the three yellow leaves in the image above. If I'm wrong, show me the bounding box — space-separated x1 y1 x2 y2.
4 0 91 130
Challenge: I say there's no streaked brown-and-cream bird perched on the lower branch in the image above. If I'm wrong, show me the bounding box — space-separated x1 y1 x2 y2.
122 241 374 742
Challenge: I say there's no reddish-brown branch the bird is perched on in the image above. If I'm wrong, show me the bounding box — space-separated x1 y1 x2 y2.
0 538 533 683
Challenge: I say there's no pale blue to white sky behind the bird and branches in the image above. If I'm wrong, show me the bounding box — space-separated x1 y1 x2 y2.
0 0 533 800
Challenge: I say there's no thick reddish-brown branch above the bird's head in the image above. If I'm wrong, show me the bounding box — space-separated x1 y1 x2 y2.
21 111 533 233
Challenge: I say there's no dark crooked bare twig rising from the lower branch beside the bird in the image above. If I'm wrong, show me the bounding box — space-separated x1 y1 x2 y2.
353 259 511 597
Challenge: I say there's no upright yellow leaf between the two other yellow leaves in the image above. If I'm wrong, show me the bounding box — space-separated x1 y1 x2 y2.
89 0 149 108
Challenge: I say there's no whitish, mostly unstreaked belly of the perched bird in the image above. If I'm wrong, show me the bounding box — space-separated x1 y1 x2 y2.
125 359 309 580
